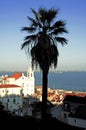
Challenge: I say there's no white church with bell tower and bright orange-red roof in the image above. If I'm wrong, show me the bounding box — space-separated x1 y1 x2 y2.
2 67 35 96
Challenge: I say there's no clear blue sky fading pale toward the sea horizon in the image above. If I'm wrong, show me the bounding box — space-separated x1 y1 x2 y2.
0 0 86 71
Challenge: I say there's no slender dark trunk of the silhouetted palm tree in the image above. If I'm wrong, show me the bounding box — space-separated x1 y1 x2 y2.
41 70 48 119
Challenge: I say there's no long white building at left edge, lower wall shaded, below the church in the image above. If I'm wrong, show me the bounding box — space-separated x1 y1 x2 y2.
0 84 23 112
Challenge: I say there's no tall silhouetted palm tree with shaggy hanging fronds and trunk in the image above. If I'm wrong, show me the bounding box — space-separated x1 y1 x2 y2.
21 8 68 118
